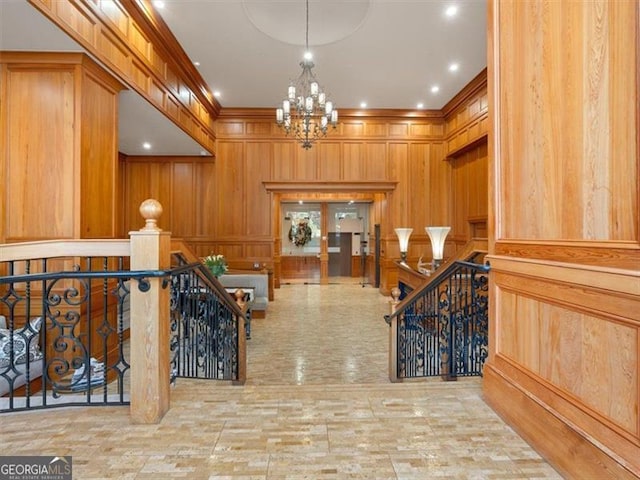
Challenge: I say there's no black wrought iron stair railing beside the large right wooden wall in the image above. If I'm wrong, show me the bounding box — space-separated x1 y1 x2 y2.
385 261 490 379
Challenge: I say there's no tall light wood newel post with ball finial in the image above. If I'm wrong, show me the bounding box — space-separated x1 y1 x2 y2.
129 199 171 423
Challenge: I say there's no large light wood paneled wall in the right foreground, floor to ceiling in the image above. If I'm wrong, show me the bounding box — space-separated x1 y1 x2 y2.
484 0 640 479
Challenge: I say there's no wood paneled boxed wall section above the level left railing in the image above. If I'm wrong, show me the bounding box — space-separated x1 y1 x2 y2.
0 52 122 243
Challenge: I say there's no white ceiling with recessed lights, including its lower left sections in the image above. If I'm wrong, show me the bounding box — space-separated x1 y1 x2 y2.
0 0 487 155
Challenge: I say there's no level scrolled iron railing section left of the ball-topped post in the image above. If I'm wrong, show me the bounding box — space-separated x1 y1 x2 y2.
0 257 142 412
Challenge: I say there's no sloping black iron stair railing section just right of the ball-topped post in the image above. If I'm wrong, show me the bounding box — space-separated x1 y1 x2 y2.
170 254 246 383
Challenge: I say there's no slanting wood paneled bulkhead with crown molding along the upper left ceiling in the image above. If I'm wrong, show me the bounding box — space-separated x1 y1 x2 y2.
29 0 220 153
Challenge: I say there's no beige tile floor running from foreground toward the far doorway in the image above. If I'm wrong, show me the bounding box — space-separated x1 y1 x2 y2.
0 282 560 480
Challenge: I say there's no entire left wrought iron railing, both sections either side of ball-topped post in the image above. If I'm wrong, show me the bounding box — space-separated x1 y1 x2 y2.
0 248 246 412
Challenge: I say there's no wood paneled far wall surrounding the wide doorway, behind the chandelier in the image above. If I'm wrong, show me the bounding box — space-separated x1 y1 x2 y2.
122 76 487 293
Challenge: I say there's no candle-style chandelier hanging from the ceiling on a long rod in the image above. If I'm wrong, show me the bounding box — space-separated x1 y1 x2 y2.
276 0 338 150
